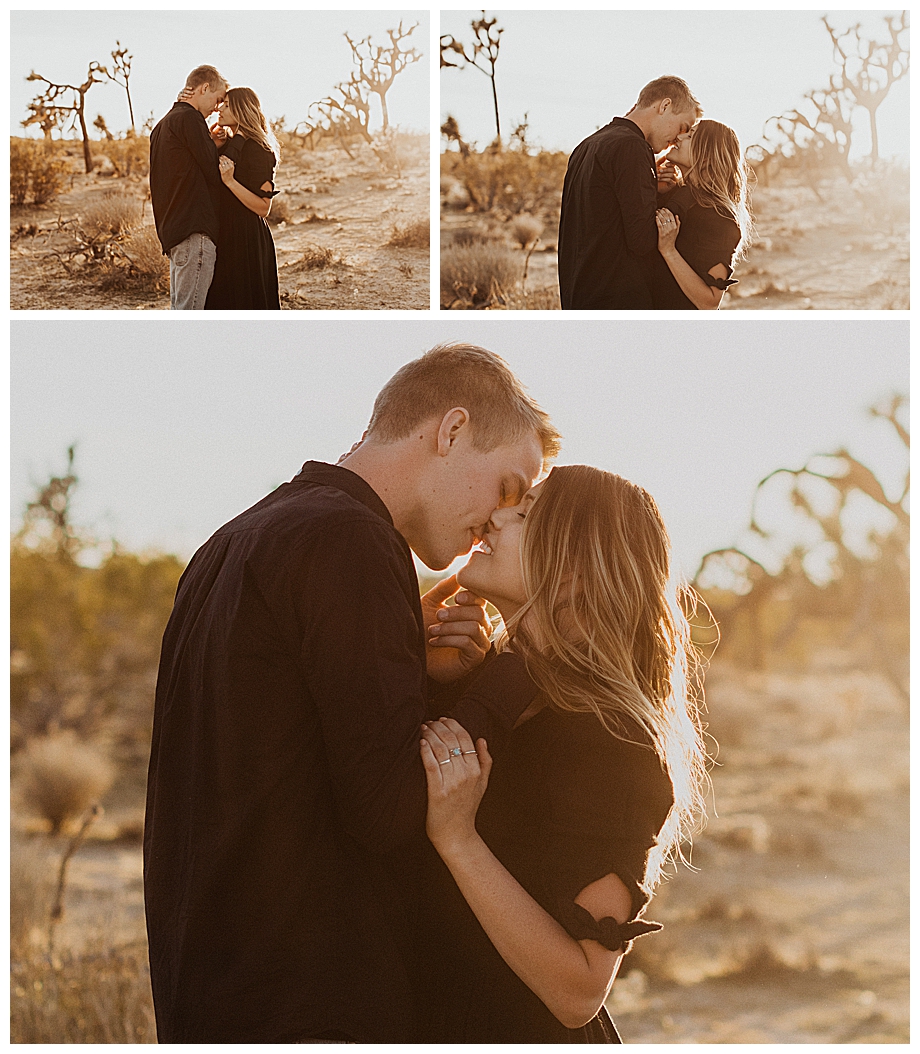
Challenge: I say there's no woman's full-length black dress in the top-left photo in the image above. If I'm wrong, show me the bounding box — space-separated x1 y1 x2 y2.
204 136 281 311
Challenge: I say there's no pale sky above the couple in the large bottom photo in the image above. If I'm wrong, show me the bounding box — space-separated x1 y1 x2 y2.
11 318 908 575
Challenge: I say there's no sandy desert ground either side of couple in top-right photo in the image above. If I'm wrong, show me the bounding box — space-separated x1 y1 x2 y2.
441 170 911 311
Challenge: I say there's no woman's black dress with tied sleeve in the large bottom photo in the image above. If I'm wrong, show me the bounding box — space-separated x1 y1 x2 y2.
420 695 672 1043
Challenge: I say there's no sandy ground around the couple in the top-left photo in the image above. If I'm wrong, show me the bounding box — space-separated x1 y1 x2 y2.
9 137 430 310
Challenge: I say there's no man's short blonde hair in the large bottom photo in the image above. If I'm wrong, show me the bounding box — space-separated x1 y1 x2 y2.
368 344 561 461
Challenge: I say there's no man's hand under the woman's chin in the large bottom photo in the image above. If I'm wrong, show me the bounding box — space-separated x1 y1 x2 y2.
422 574 492 684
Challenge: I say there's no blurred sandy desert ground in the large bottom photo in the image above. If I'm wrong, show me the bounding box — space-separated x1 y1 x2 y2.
14 653 909 1043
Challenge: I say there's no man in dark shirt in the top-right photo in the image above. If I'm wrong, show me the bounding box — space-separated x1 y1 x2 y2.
559 77 703 311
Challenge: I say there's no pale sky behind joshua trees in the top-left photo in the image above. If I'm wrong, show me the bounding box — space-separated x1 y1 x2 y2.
9 8 431 138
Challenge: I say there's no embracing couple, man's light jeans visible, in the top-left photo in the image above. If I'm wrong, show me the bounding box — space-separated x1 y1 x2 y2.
150 65 280 311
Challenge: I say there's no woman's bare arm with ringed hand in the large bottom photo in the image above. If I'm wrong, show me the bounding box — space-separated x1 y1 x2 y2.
422 718 631 1029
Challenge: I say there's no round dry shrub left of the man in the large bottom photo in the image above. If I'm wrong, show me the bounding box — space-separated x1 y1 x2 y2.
17 731 115 834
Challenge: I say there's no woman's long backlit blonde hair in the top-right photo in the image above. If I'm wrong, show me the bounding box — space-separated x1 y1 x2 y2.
684 120 755 256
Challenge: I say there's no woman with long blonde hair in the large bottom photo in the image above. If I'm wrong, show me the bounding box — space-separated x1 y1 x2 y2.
420 466 706 1042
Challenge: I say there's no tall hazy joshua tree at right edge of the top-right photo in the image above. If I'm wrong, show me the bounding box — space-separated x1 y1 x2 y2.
821 11 911 164
